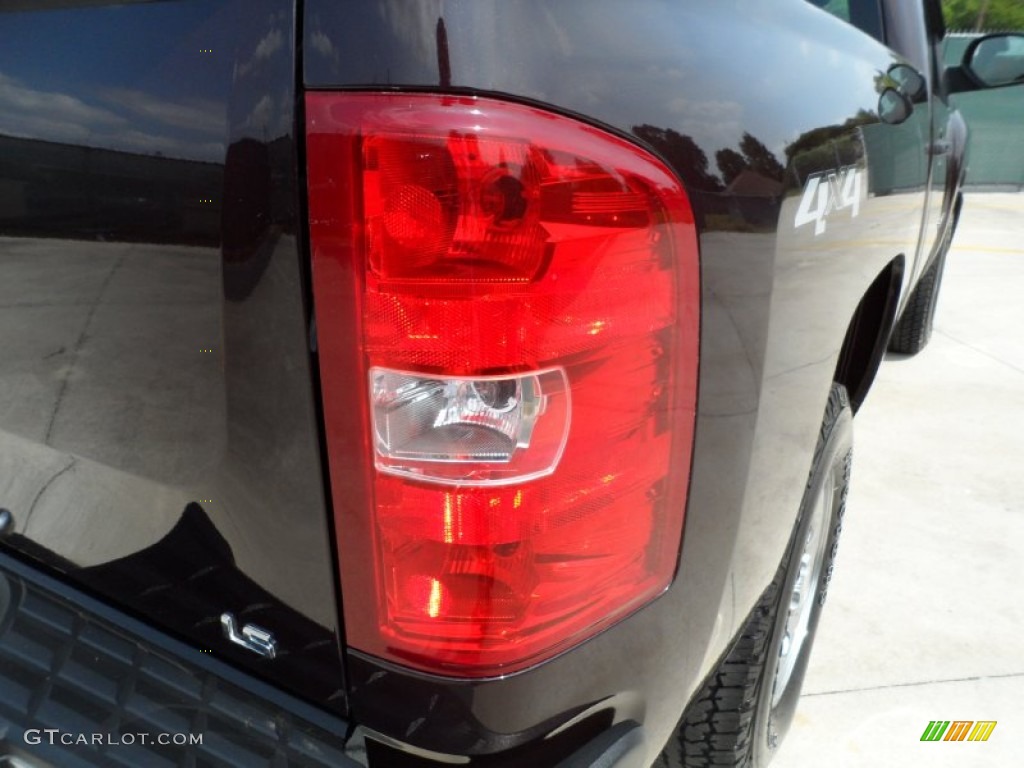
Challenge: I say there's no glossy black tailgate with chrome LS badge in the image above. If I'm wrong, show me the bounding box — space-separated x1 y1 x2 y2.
0 0 345 711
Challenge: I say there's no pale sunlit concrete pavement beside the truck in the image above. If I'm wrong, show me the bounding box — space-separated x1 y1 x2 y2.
773 194 1024 768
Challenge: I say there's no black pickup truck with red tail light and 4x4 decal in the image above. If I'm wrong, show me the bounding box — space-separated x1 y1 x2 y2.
0 0 1019 768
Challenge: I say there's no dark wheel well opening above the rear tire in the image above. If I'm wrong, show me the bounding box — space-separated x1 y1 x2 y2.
834 256 903 413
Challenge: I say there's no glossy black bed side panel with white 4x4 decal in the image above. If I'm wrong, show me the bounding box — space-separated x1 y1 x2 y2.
303 0 928 759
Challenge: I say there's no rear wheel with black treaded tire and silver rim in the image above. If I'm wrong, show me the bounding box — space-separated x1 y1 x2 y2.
654 385 853 768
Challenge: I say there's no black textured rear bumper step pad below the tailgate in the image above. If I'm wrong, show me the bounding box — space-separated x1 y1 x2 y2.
0 553 359 768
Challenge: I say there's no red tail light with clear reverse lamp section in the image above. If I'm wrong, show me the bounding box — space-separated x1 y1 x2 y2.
306 93 699 677
